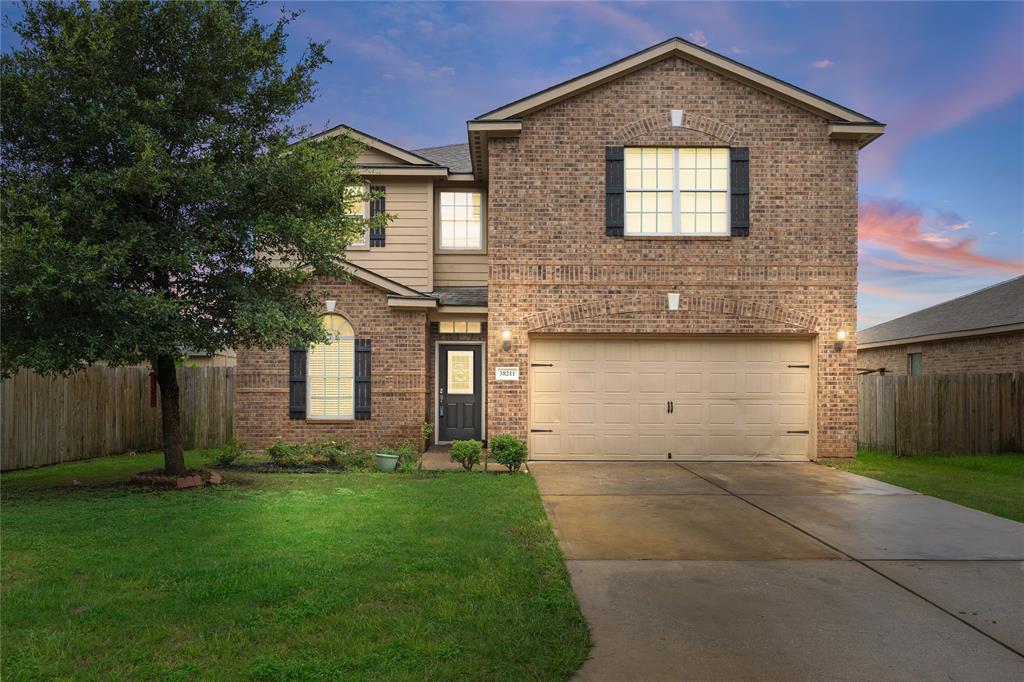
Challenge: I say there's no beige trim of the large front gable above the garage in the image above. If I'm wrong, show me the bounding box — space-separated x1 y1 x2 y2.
473 37 882 125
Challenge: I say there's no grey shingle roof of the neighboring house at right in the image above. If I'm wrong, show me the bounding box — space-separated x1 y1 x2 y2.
857 275 1024 345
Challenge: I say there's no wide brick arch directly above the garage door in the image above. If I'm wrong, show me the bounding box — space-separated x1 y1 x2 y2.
523 293 821 333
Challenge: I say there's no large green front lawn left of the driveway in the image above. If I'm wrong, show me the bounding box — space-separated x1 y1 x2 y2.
0 452 590 681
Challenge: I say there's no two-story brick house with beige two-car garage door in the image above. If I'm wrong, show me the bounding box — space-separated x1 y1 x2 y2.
236 38 885 460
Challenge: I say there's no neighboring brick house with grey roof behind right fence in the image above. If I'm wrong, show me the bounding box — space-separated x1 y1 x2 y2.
857 276 1024 375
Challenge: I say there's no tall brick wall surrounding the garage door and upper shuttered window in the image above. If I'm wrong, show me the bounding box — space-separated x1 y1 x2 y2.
487 58 857 457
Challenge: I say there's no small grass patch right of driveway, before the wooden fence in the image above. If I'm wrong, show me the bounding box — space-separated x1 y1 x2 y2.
829 451 1024 522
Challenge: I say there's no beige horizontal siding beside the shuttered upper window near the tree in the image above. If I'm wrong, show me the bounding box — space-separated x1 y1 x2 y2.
348 177 433 291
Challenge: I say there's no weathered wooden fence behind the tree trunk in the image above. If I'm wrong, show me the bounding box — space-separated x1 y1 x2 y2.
0 367 234 471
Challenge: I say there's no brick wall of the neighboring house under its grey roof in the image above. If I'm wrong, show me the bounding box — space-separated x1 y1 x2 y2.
857 332 1024 375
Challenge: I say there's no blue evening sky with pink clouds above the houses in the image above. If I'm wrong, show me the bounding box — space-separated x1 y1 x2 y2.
3 0 1024 329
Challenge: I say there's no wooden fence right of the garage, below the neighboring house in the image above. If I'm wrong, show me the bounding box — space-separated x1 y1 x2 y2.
857 374 1024 455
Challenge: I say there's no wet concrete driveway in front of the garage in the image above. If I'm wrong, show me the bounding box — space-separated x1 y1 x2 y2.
530 462 1024 681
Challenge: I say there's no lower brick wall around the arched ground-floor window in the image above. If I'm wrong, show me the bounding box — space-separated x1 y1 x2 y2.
234 280 427 447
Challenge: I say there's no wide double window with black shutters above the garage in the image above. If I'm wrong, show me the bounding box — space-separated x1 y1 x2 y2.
626 146 729 236
